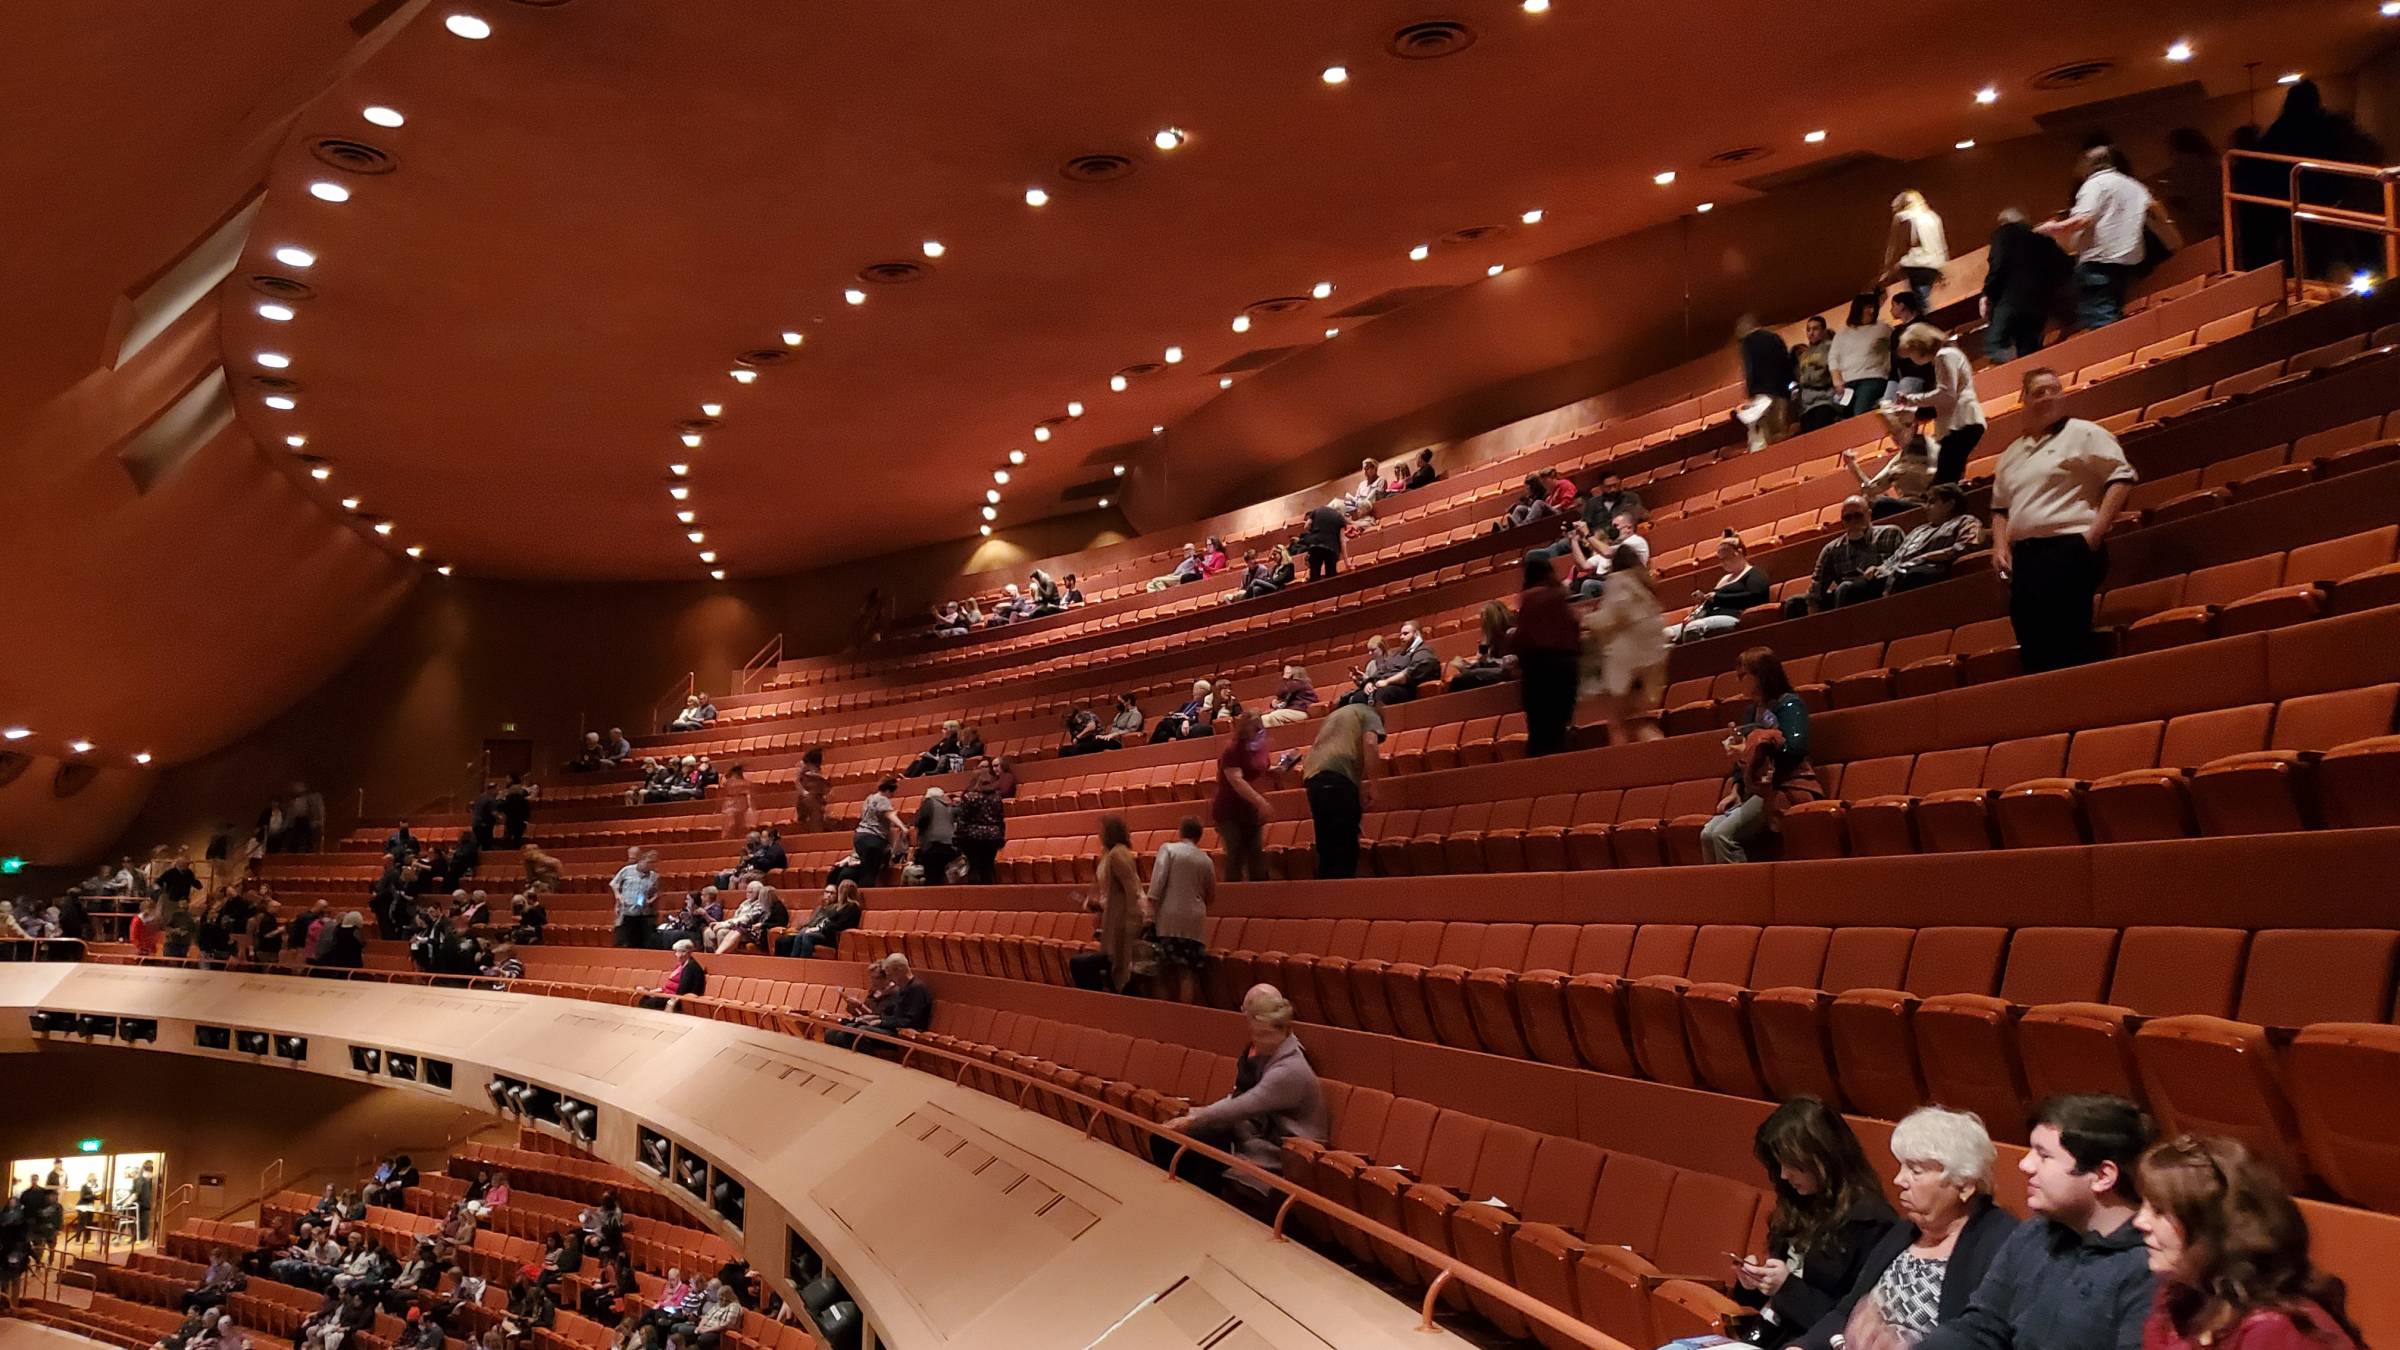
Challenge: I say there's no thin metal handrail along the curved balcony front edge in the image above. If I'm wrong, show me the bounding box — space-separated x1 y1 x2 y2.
51 951 1630 1350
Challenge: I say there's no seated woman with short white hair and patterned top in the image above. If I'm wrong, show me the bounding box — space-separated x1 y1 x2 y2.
1793 1107 2016 1350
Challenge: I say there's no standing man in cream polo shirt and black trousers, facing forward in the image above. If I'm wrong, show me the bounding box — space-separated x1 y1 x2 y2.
1992 368 2136 673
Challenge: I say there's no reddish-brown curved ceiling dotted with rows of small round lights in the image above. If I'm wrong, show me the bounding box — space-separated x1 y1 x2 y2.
238 0 2390 577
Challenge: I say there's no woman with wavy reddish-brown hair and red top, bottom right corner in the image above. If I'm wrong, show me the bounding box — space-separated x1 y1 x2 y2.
2134 1134 2359 1350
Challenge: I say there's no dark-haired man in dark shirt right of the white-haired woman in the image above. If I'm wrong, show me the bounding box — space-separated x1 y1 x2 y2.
1918 1093 2153 1350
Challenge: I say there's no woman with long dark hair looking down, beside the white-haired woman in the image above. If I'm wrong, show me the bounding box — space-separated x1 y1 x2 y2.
1733 1098 1894 1348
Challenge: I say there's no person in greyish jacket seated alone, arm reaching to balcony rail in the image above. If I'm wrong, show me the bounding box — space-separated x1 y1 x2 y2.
1150 985 1332 1196
